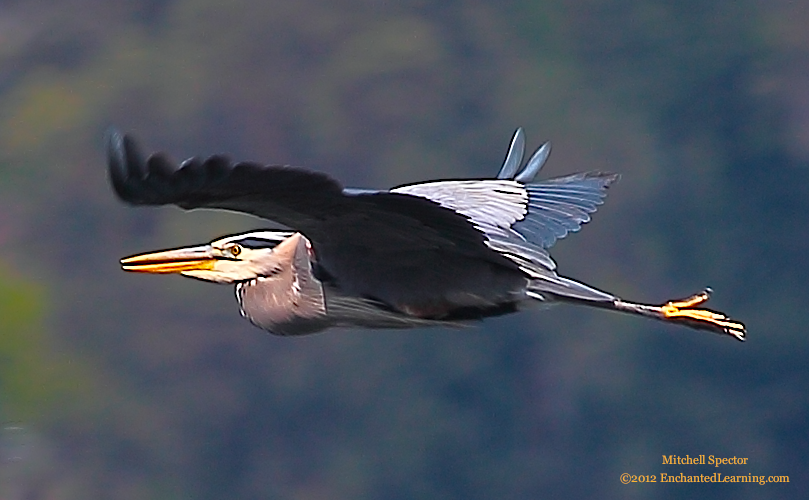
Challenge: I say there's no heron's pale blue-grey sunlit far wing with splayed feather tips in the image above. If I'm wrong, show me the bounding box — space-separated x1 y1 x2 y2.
391 128 618 300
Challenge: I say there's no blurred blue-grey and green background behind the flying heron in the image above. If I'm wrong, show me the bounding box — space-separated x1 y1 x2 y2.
0 0 809 500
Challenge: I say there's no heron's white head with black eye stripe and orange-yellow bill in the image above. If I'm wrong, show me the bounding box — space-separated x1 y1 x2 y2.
121 231 297 283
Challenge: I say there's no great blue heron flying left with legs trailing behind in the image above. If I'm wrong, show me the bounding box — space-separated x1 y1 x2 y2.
107 129 745 340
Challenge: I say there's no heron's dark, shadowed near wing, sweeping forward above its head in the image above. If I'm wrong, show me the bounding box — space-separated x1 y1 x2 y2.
107 132 524 308
